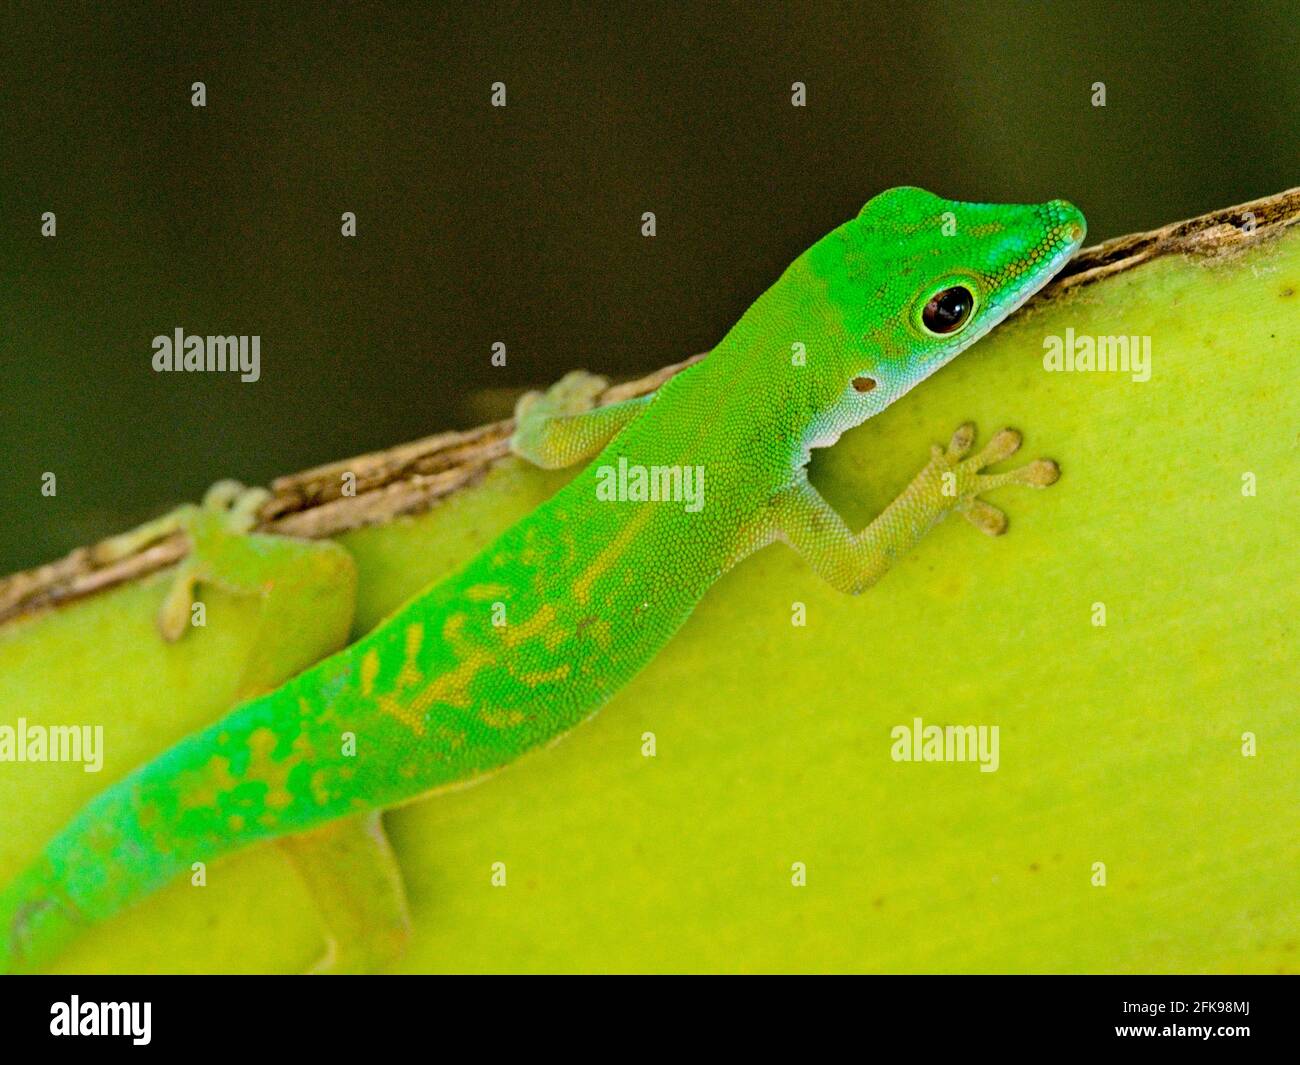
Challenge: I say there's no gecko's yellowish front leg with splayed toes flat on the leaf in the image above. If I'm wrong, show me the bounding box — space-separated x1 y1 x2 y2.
772 423 1061 596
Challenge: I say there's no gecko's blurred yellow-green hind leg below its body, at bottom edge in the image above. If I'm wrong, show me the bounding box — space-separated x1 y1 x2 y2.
280 810 411 973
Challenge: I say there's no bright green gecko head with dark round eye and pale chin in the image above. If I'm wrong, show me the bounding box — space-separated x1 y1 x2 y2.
809 187 1087 421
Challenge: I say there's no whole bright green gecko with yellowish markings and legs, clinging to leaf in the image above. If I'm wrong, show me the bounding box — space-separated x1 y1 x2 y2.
0 187 1086 971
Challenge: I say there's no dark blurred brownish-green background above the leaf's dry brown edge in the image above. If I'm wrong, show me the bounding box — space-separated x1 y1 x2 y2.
0 3 1300 572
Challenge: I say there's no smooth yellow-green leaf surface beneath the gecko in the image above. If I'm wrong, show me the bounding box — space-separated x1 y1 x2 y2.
0 221 1300 973
